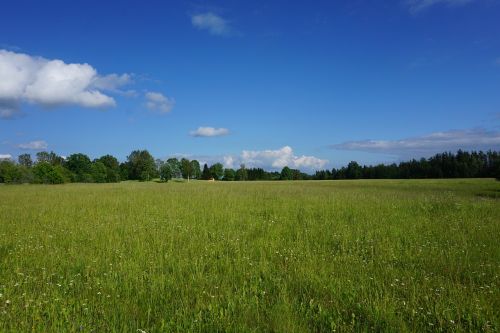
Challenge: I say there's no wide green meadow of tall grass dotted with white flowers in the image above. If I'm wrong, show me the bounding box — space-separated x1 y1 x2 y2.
0 180 500 333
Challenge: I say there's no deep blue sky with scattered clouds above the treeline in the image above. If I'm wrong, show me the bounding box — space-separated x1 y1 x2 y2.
0 0 500 172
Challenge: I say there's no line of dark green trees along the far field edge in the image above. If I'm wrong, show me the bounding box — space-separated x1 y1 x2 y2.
0 150 500 184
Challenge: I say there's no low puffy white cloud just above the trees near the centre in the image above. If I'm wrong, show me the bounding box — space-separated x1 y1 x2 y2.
241 146 328 170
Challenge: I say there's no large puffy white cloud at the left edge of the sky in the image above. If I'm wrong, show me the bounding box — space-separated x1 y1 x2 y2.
0 50 130 118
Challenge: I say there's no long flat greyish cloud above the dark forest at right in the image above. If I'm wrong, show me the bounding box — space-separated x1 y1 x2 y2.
331 129 500 156
